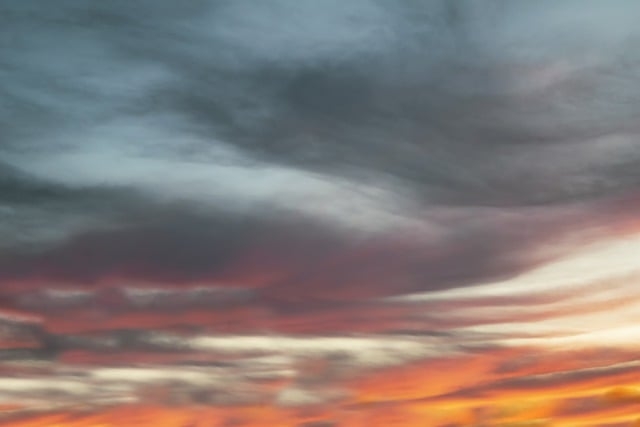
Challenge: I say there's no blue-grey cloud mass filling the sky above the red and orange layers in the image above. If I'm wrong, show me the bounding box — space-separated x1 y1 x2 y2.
0 0 640 295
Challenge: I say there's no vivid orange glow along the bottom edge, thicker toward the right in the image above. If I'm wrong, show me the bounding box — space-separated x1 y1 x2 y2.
1 351 640 427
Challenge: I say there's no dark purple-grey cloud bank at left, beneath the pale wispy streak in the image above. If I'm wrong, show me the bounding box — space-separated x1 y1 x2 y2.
0 205 356 284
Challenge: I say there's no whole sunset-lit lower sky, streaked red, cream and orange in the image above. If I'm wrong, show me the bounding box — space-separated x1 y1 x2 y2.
0 239 640 427
